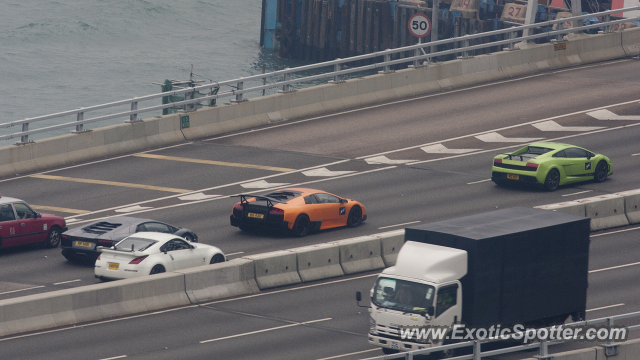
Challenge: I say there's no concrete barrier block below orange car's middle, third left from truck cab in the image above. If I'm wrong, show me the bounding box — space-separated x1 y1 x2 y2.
291 244 344 282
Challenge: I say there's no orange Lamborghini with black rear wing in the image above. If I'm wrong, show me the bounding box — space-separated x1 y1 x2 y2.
231 188 367 237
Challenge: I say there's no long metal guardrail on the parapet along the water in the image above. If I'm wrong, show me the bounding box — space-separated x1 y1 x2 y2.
5 6 640 145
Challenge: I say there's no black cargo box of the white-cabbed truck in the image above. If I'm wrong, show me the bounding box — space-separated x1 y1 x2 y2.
405 207 590 326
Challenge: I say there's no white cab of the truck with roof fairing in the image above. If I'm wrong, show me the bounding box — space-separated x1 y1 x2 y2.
368 241 467 354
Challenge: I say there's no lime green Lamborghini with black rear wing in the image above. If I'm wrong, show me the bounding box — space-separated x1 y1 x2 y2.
491 142 613 191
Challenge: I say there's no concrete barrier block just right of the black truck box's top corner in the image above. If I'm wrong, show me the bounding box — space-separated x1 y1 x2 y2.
575 194 629 231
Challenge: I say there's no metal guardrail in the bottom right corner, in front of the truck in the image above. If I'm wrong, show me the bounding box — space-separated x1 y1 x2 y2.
364 311 640 360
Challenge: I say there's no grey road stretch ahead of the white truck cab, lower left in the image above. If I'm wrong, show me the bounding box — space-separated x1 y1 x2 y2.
0 276 380 359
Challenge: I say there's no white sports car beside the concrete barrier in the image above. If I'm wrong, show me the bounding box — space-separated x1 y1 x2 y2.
95 232 226 280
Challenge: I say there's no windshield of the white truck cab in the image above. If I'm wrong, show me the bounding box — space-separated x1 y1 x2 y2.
371 277 434 313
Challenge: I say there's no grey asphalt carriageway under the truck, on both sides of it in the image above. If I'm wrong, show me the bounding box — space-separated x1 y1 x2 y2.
0 228 640 360
